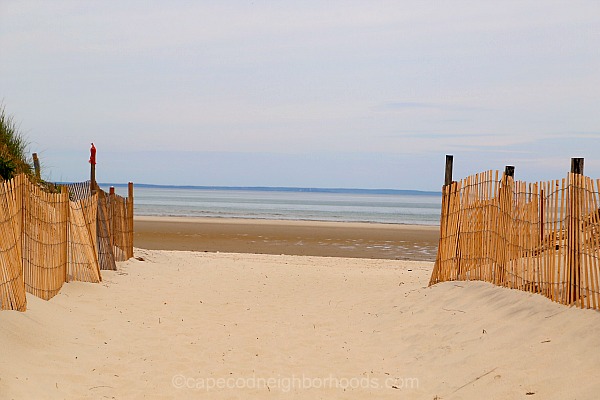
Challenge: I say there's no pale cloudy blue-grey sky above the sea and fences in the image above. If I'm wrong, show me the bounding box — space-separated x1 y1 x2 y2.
0 0 600 190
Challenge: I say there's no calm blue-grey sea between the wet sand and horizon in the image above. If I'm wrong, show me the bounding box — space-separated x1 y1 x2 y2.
103 185 441 225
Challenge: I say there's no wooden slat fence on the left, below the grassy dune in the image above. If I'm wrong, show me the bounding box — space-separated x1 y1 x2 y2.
0 175 133 311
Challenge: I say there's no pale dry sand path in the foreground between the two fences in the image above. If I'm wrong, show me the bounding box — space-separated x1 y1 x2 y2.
0 245 600 400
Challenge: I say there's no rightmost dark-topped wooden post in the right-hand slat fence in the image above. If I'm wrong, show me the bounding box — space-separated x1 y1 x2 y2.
567 158 583 304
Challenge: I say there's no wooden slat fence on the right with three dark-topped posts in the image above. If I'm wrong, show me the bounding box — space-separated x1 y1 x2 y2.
429 159 600 309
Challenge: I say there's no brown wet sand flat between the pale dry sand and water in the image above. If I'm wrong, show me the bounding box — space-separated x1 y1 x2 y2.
134 216 439 261
